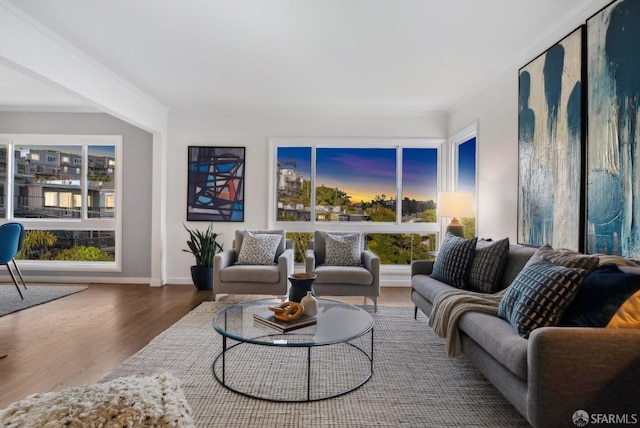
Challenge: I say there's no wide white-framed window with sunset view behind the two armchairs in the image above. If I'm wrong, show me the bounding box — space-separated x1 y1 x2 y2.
271 139 442 265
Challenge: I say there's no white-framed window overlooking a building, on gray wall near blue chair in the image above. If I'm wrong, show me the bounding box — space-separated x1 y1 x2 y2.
0 134 122 270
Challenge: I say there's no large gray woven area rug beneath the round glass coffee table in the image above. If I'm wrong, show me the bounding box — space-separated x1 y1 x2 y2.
102 302 529 428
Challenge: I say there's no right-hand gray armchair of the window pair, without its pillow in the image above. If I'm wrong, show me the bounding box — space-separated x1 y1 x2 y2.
306 231 380 312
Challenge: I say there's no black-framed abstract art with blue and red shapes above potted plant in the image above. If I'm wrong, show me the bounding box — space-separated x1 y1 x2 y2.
187 146 245 222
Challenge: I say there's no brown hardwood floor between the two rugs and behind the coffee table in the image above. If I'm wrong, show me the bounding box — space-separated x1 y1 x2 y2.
0 284 412 409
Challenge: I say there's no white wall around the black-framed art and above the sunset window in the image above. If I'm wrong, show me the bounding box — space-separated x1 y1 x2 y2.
167 111 447 284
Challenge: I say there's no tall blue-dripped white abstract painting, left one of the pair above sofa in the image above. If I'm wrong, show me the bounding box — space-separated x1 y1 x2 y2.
518 27 584 250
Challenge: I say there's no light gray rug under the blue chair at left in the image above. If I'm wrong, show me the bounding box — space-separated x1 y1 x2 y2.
0 284 87 317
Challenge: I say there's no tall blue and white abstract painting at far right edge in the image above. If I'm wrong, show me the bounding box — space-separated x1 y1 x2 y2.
586 0 640 258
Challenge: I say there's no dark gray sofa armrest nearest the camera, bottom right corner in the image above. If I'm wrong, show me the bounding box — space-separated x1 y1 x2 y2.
527 327 640 427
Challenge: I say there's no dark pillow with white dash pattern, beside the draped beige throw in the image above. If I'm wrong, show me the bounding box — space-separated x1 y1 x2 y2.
498 257 587 339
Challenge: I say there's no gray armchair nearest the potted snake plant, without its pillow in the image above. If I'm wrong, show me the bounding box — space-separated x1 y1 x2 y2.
213 230 293 299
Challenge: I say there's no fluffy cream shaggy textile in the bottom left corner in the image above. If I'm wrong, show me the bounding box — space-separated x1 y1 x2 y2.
0 373 193 428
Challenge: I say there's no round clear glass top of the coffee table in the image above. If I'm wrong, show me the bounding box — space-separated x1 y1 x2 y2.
213 299 373 346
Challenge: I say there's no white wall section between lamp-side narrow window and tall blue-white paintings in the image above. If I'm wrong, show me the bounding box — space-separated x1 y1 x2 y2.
448 0 609 242
